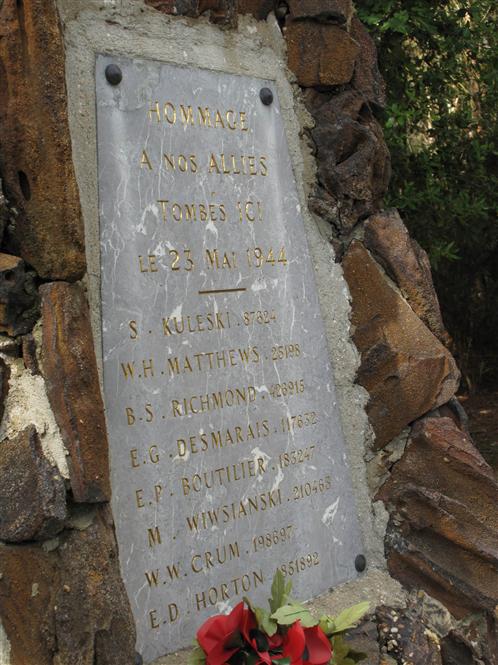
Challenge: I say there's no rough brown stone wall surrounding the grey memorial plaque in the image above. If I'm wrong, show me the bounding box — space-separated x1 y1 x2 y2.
0 0 498 665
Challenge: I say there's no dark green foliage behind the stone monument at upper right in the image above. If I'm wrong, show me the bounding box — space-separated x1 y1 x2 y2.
356 0 498 387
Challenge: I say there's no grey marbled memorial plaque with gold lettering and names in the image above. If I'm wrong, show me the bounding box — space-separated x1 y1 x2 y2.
96 56 361 662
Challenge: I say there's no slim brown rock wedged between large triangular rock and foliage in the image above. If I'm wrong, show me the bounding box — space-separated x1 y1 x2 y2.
365 210 449 345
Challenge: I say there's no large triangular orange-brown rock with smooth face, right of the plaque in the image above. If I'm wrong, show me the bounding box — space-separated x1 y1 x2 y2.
343 241 459 448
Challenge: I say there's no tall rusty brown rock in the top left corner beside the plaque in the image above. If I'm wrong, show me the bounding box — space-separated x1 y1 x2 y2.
0 0 85 280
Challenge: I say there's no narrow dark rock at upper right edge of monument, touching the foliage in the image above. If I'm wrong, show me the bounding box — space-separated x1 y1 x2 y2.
350 16 386 108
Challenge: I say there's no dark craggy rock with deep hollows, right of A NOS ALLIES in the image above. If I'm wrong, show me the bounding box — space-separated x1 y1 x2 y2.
305 90 391 236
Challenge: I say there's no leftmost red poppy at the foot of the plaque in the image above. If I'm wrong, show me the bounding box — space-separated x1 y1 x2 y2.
197 602 248 665
